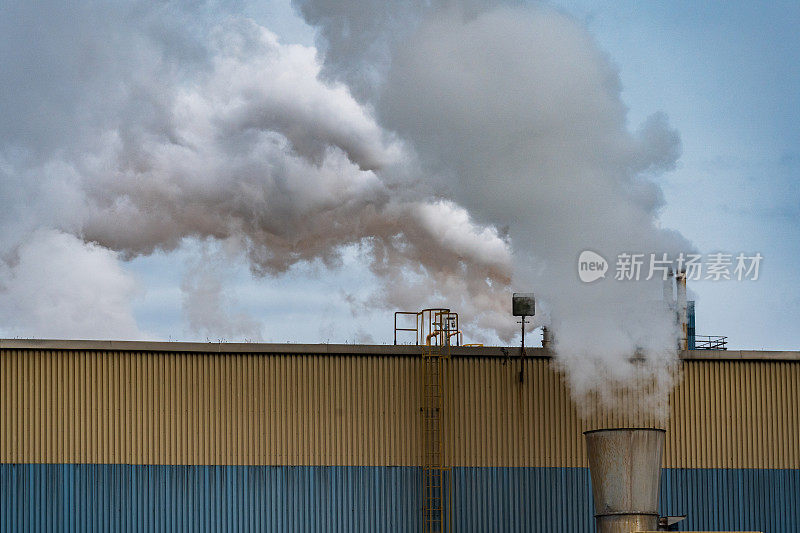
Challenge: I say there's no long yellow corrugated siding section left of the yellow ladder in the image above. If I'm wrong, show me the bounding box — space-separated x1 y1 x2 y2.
0 350 421 465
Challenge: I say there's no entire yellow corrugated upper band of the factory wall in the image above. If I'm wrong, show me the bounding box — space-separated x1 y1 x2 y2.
0 349 800 468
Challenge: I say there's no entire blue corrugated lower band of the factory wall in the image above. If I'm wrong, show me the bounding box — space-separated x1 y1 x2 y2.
0 464 800 533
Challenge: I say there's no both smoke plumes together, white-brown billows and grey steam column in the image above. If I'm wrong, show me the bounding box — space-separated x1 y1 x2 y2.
0 0 689 416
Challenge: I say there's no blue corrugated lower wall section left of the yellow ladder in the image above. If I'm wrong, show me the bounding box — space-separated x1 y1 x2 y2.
0 464 422 532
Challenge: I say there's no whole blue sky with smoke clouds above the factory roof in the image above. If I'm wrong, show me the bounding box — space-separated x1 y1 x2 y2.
0 0 800 350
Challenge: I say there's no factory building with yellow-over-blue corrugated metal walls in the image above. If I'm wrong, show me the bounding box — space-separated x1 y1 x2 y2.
0 340 800 533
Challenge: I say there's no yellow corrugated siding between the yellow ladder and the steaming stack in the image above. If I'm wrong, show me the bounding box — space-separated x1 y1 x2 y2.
444 358 663 466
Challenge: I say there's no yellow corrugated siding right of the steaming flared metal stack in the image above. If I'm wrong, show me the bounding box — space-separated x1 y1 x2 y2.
666 361 800 468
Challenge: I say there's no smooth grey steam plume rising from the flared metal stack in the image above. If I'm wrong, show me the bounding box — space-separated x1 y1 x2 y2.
298 0 690 416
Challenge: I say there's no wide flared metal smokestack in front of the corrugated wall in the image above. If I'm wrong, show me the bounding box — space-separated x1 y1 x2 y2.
584 428 665 533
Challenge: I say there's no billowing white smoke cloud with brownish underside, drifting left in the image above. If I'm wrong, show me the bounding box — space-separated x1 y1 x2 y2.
0 2 511 337
